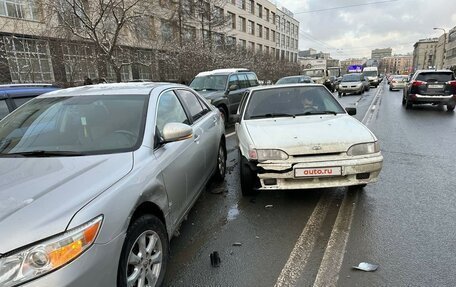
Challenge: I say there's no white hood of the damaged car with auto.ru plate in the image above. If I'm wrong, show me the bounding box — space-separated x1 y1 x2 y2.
246 114 376 155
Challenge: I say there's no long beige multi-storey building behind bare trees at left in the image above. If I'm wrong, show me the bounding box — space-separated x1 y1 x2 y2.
0 0 299 85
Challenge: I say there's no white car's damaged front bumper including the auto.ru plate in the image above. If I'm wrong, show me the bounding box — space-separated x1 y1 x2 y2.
249 153 383 190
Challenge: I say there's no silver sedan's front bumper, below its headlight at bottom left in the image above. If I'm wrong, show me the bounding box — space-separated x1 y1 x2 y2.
21 234 125 287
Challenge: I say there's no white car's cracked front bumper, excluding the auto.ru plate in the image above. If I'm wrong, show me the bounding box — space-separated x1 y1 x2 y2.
257 154 383 190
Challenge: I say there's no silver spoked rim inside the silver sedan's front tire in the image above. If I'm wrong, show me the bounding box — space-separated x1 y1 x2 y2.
126 230 163 287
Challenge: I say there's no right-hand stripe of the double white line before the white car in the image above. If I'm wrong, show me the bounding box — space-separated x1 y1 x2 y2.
313 190 359 287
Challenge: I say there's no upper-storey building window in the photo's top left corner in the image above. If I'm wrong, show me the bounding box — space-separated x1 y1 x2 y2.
0 0 38 20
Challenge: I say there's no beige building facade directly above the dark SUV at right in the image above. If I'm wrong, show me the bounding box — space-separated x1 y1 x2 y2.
412 38 438 71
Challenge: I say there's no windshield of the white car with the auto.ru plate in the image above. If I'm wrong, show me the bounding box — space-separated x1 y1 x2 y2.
244 86 345 120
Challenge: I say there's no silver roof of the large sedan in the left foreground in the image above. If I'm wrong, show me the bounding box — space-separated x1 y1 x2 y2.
37 82 189 98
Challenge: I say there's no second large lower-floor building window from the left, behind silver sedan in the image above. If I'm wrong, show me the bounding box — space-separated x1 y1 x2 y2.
62 43 98 82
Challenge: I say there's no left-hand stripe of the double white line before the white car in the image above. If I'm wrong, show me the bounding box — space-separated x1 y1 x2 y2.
274 192 334 287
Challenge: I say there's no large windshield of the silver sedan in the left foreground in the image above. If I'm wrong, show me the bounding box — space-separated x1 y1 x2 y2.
0 95 147 156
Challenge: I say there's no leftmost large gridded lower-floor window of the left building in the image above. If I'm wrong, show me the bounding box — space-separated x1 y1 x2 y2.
3 37 54 83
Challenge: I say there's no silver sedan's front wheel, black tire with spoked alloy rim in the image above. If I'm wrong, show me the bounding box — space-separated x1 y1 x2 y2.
117 214 169 287
